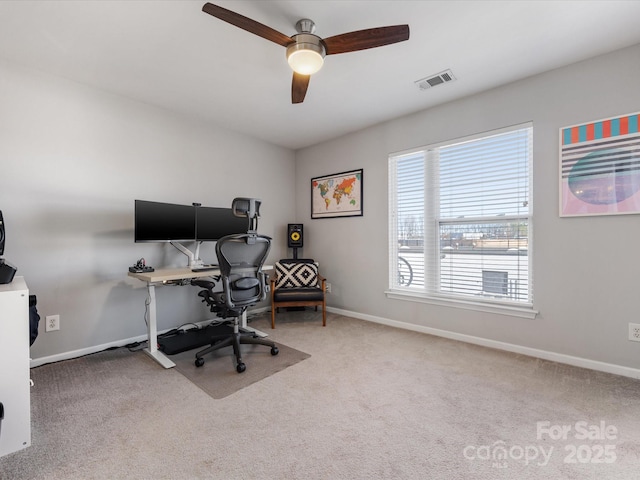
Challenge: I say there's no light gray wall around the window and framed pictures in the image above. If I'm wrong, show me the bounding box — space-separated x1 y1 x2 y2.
296 46 640 368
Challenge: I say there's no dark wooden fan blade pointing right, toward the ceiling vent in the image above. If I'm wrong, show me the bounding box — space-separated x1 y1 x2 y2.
322 25 409 55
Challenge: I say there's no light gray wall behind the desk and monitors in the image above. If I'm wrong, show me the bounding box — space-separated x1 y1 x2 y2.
0 58 294 360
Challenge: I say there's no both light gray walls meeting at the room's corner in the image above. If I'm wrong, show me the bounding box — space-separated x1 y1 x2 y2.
5 39 640 374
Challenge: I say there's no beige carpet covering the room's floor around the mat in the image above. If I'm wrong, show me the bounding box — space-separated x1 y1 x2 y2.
0 312 640 480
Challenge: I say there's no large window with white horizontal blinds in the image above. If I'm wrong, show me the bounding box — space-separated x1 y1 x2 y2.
387 124 535 317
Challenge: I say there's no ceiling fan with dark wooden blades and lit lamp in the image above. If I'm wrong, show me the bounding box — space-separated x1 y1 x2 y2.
202 3 409 103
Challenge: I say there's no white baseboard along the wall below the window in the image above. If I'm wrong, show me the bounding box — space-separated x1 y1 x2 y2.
327 307 640 379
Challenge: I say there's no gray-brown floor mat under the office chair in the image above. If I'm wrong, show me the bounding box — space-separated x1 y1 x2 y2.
169 343 310 399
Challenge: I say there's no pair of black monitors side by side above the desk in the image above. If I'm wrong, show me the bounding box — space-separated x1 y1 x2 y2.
134 198 261 268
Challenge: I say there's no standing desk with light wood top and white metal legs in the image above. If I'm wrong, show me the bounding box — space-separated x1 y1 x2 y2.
129 265 273 368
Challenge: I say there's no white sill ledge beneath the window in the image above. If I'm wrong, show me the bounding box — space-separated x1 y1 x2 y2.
385 290 538 319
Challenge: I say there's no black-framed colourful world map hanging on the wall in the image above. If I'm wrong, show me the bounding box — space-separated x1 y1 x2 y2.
311 169 362 219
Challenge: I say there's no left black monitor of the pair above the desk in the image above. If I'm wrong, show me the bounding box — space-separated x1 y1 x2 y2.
134 200 196 242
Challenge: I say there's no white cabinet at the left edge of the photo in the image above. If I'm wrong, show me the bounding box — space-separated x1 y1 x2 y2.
0 277 31 457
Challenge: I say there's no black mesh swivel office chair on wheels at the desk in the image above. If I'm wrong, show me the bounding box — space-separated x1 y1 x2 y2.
191 232 278 373
